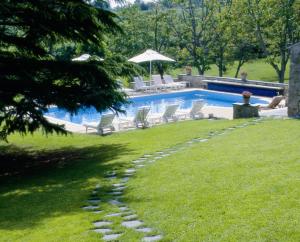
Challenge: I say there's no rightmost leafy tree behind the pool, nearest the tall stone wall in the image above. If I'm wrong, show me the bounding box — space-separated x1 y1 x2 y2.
245 0 300 82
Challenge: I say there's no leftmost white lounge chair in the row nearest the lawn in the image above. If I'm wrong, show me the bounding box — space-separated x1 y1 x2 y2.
83 114 116 135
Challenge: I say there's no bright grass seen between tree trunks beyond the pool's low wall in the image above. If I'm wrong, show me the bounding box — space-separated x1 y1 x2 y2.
170 60 290 82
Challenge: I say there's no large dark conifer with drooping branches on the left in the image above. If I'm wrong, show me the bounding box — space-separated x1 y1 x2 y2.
0 0 131 139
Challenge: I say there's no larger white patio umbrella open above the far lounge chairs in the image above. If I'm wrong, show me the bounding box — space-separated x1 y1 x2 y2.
128 50 175 79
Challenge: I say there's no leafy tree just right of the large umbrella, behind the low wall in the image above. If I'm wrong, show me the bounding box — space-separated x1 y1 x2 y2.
169 0 215 75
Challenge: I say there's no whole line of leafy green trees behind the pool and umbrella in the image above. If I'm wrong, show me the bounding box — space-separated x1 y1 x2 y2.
108 0 300 82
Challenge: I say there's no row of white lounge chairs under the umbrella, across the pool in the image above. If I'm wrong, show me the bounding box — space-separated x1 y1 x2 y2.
133 75 186 91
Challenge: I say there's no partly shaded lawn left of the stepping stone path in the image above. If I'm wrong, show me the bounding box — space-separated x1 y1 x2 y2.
0 120 246 241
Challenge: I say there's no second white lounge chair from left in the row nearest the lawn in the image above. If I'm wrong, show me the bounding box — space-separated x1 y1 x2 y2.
119 106 150 129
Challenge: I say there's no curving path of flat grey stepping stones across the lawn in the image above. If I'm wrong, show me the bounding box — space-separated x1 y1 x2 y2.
82 119 263 242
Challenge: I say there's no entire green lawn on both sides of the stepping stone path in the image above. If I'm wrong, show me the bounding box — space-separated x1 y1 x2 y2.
0 120 300 242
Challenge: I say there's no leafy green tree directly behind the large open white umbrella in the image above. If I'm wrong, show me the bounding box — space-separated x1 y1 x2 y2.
108 3 173 75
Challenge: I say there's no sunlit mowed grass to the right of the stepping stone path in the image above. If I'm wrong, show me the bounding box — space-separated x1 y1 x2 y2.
126 120 300 241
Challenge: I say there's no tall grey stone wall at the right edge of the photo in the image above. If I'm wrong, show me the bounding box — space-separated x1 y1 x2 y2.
288 43 300 117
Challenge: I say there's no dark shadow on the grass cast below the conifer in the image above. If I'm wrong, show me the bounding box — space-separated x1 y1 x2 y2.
0 144 134 230
